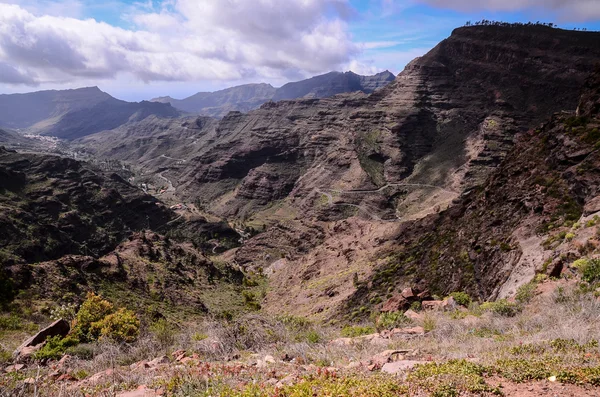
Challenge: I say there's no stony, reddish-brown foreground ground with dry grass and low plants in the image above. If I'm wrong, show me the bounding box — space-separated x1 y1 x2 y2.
0 277 600 397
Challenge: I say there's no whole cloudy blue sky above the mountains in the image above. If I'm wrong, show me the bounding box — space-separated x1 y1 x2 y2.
0 0 600 101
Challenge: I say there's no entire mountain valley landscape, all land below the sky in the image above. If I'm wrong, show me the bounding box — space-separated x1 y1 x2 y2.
0 21 600 397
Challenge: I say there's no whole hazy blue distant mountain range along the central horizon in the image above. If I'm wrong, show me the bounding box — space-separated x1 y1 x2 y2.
151 70 395 118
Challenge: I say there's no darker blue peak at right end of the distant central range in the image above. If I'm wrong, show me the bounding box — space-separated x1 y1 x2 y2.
272 70 395 101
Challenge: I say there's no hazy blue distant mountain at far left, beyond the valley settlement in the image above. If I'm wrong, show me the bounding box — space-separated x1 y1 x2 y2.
0 87 179 139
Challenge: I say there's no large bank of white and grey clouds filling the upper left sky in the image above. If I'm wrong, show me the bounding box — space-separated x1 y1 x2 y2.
0 0 359 84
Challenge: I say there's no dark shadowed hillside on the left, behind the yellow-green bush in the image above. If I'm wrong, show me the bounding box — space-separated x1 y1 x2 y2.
0 146 242 315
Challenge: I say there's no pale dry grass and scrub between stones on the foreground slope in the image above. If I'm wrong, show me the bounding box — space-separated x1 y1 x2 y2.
0 281 600 396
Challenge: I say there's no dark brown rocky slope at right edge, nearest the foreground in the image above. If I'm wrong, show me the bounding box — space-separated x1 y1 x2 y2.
347 68 600 310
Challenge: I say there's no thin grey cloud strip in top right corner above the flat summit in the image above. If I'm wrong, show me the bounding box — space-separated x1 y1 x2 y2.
420 0 600 21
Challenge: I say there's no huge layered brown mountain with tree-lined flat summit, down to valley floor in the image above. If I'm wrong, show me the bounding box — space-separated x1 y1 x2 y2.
32 26 600 318
